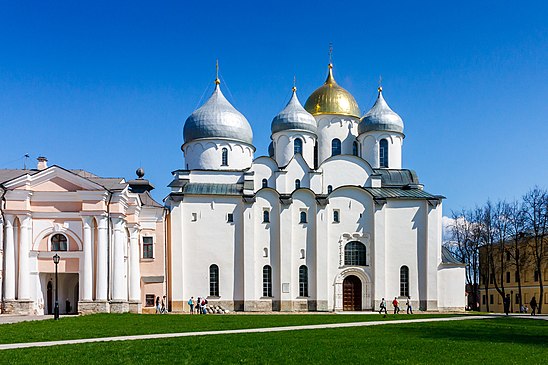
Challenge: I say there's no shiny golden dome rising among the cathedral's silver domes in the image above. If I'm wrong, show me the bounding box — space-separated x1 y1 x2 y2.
304 64 360 118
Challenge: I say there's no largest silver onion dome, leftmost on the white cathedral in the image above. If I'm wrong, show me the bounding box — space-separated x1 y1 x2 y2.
183 83 253 144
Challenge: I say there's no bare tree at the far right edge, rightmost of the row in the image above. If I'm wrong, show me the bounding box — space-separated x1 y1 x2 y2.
523 187 548 313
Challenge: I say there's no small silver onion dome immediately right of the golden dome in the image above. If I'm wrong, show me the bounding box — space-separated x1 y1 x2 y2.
358 87 403 134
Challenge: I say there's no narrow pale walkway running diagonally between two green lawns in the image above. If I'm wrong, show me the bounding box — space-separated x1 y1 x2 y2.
0 315 496 350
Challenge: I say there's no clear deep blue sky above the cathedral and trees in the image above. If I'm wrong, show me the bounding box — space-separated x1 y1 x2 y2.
0 1 548 215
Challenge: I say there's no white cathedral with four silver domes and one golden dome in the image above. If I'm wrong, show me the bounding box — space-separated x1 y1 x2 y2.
166 64 465 311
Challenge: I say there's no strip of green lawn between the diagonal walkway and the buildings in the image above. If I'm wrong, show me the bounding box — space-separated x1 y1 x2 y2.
0 313 458 343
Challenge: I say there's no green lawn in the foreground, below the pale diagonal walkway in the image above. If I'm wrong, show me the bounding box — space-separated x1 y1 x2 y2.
0 316 548 365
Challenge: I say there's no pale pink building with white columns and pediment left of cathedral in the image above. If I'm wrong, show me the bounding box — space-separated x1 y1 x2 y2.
0 161 166 314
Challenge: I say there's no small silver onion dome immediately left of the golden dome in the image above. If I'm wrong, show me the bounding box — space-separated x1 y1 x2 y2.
271 87 318 134
